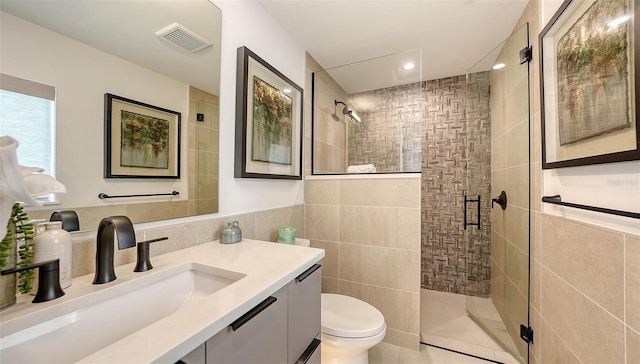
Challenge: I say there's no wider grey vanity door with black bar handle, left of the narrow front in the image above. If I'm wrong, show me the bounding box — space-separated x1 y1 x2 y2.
206 286 288 364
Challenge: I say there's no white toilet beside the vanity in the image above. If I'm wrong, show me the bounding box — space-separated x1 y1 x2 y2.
321 293 387 364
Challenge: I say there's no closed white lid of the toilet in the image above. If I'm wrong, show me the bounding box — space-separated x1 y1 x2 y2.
321 293 385 338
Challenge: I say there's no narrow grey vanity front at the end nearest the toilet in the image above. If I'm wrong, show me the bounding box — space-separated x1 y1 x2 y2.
287 264 322 363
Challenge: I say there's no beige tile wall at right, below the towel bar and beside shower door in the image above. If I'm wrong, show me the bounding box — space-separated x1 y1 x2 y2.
517 0 640 364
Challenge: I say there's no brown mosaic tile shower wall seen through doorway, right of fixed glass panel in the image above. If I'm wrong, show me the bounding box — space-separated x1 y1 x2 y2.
421 72 491 296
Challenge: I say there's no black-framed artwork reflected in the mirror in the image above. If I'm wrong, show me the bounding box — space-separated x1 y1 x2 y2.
104 94 181 179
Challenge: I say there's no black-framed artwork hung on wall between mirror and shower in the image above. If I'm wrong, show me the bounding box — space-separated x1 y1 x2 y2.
235 47 302 179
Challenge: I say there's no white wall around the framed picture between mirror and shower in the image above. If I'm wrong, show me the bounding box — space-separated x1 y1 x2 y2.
212 0 310 215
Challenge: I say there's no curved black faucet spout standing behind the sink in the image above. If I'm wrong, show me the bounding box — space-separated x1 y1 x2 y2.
93 216 136 284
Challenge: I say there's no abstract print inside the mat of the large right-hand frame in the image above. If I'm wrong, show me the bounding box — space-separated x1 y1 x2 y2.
557 0 631 145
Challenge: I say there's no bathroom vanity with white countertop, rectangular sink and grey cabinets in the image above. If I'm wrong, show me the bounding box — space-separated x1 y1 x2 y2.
0 239 324 364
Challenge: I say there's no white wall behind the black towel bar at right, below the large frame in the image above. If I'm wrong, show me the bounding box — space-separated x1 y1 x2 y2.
534 0 640 235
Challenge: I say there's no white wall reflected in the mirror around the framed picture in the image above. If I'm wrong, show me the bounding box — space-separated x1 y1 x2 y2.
0 12 189 207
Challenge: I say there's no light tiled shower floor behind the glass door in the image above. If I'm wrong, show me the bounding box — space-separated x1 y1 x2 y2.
420 289 519 364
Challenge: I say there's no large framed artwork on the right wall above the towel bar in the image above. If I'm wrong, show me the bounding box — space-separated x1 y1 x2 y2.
539 0 640 169
